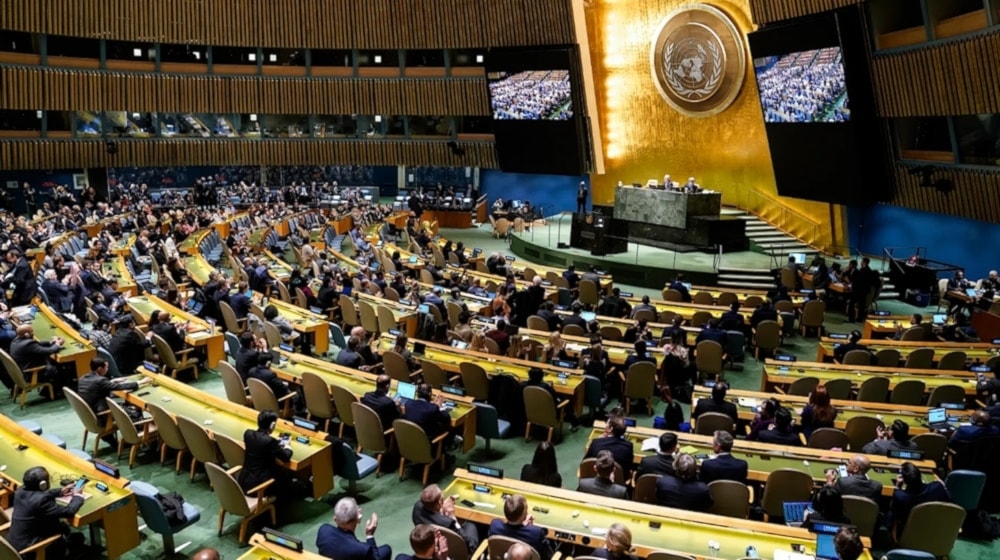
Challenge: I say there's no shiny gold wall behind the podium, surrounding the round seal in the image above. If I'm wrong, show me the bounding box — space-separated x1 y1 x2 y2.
587 0 843 246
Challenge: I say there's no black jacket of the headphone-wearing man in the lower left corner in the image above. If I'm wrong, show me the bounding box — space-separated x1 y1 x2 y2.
7 488 83 550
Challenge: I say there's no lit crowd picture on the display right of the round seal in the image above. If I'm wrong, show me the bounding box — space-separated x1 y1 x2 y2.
753 46 851 123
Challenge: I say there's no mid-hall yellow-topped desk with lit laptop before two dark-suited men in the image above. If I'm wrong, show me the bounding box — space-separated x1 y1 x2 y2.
271 350 476 453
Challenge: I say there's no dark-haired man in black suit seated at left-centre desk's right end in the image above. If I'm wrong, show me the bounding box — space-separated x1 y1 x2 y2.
238 410 292 500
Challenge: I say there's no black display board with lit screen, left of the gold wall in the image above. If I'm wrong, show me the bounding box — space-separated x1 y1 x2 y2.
485 46 589 175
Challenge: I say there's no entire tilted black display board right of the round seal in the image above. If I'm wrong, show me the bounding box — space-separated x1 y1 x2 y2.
747 6 892 206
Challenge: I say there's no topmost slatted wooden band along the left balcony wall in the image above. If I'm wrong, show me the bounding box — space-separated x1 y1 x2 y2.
0 0 574 49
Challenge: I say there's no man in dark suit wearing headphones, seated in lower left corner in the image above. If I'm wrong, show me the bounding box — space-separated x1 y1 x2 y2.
7 467 83 559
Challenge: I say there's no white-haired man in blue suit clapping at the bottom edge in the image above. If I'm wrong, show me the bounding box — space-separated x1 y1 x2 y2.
316 498 392 560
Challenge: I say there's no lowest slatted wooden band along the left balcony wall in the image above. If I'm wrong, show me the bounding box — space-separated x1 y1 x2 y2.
0 138 498 169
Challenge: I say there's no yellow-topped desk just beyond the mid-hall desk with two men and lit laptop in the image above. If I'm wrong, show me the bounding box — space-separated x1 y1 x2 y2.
379 333 584 416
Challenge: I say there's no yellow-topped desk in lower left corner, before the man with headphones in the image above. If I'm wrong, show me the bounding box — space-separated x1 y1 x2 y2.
0 414 139 558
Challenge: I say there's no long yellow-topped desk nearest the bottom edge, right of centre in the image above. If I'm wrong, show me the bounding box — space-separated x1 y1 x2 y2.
443 469 871 560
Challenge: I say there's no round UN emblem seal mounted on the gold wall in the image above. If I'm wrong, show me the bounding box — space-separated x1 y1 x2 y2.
650 4 746 117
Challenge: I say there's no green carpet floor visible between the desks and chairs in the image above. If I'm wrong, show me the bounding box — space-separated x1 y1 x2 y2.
11 227 1000 560
